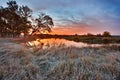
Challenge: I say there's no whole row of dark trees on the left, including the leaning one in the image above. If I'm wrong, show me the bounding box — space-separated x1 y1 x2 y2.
0 0 53 37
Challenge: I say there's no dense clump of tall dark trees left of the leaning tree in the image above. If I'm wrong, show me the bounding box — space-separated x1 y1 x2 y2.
0 0 32 37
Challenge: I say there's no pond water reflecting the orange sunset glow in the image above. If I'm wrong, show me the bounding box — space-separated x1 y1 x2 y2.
27 38 120 48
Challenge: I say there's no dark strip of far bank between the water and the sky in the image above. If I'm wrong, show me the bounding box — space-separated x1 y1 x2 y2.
33 34 120 44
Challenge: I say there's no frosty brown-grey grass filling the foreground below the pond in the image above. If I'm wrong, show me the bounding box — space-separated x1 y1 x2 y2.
0 38 120 80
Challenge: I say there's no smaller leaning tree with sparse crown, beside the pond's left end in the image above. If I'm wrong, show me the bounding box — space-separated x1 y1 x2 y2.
32 13 54 35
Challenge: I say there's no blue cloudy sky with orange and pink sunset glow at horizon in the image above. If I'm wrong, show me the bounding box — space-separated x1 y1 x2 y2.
0 0 120 35
